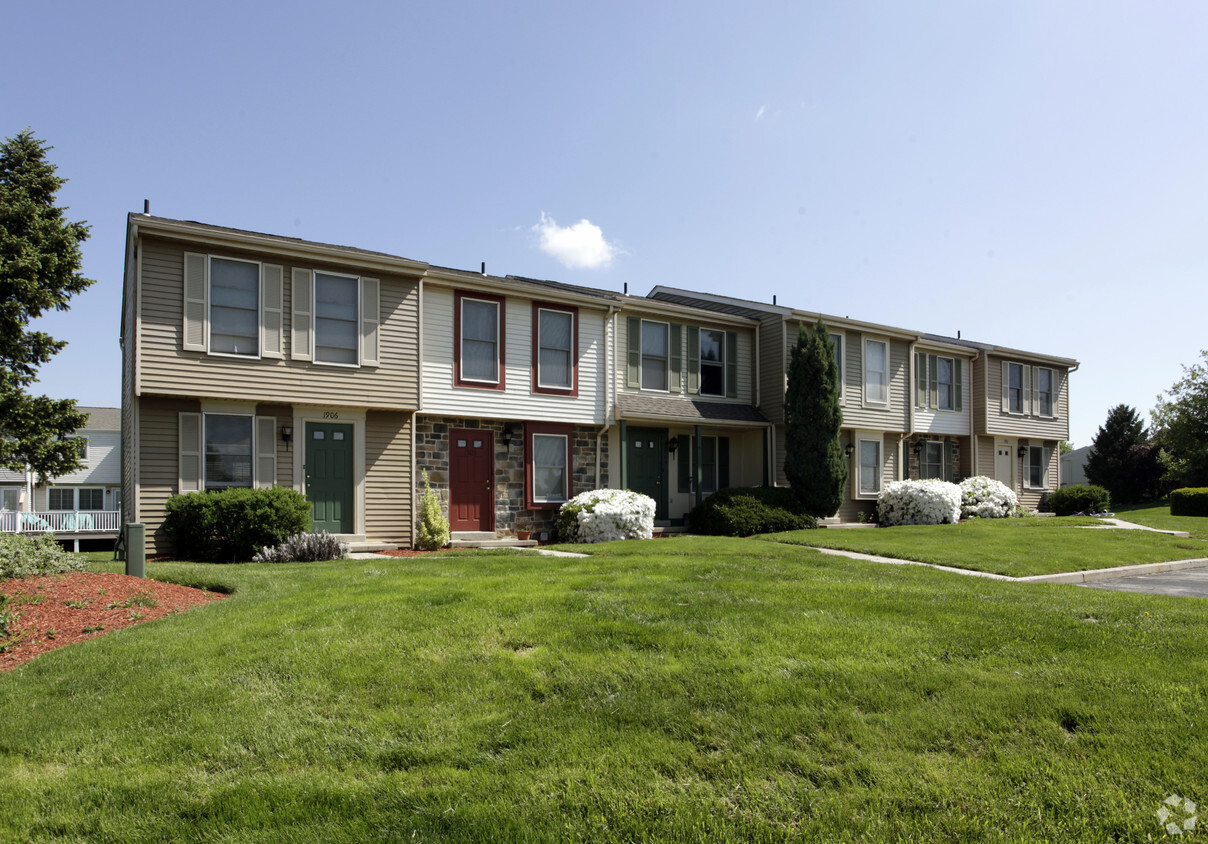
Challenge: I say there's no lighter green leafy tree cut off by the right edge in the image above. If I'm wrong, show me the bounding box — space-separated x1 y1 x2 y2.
1152 350 1208 489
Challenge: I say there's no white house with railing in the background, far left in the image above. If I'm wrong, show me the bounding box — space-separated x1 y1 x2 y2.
0 407 122 551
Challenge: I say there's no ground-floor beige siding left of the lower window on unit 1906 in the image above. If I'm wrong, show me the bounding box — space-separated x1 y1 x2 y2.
138 396 202 554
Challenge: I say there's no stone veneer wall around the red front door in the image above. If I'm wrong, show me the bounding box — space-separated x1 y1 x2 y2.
416 417 608 537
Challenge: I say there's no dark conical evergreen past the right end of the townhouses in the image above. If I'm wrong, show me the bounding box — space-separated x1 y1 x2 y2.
1085 404 1158 504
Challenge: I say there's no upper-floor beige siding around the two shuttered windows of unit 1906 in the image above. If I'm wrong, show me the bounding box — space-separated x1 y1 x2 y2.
138 239 419 409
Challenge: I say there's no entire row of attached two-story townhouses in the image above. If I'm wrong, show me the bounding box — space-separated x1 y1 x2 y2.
122 214 1078 553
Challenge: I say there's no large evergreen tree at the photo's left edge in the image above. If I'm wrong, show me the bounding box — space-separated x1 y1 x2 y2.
0 129 93 478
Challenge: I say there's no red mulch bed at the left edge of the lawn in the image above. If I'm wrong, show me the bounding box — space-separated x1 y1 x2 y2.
0 571 226 671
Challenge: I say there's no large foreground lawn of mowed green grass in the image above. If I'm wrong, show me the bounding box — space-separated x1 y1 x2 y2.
0 531 1208 842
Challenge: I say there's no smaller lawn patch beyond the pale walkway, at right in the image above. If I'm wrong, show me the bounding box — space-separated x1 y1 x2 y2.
761 517 1208 577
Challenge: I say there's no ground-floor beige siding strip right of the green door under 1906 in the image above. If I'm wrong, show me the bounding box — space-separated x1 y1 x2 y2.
365 411 416 547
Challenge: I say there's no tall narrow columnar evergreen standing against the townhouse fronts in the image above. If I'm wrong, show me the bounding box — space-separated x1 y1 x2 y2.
784 319 847 517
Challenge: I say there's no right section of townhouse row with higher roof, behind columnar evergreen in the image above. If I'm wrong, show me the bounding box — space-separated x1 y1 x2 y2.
650 286 1078 522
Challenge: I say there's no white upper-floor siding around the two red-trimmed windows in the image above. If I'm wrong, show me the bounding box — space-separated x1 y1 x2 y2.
423 283 605 425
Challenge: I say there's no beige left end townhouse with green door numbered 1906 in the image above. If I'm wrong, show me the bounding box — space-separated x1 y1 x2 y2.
121 214 428 553
